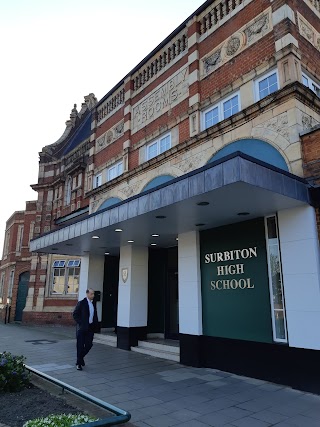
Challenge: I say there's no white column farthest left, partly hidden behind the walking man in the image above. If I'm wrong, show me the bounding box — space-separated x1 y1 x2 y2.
79 254 104 321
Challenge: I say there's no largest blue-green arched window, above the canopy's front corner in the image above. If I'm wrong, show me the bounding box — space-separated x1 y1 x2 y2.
208 139 289 171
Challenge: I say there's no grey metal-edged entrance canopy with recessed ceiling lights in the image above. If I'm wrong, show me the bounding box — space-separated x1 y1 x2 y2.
30 152 311 256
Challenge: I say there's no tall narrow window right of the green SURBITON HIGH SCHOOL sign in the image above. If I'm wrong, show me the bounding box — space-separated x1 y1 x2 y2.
265 215 287 342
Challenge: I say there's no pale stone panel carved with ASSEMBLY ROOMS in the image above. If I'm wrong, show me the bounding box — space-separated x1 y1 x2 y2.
132 67 189 133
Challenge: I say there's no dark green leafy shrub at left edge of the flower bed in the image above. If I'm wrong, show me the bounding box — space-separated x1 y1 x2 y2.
0 351 30 393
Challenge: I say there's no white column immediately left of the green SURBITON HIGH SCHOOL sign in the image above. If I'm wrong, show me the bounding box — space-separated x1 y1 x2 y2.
178 231 202 335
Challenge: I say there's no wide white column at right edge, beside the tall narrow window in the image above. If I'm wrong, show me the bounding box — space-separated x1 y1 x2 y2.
278 206 320 350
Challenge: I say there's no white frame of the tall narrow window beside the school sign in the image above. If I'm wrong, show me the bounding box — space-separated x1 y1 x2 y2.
264 214 288 343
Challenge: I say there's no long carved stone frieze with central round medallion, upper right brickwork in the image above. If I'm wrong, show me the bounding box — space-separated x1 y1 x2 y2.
200 8 272 79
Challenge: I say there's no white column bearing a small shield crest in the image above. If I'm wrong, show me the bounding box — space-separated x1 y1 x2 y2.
118 245 148 328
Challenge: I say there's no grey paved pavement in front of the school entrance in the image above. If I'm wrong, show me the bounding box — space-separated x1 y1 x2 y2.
0 324 320 427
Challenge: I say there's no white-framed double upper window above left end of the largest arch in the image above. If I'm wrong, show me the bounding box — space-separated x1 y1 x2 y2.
203 93 241 129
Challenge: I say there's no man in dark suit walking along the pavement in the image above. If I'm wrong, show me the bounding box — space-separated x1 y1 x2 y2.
73 288 98 371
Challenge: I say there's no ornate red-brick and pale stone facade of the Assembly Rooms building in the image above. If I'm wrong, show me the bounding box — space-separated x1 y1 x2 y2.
0 0 320 323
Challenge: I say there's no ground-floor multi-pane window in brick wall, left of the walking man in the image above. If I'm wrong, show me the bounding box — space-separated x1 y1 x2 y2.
51 259 80 295
